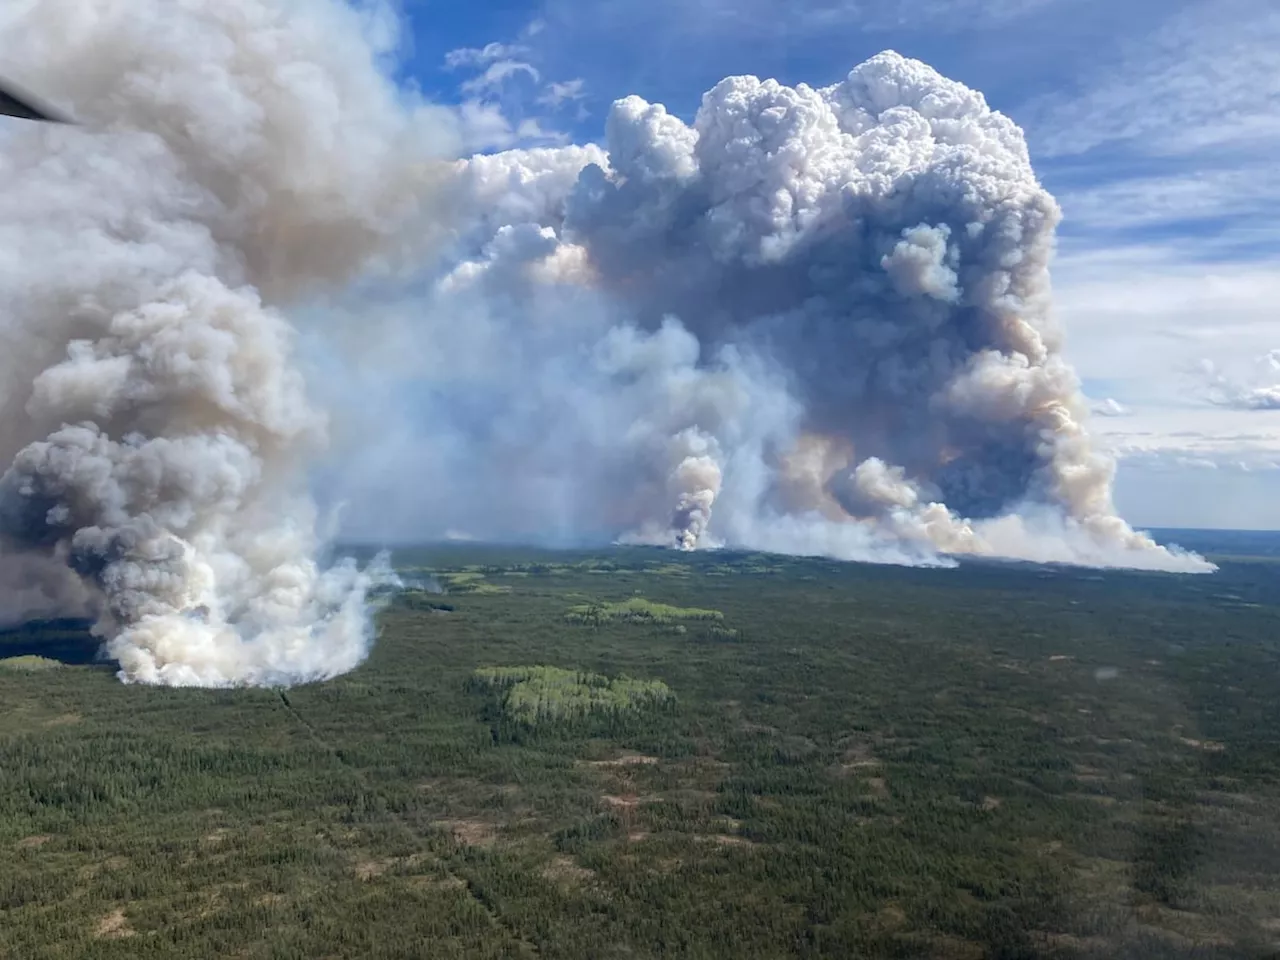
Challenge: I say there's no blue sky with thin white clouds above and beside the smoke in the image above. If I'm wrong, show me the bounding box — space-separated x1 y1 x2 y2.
386 0 1280 527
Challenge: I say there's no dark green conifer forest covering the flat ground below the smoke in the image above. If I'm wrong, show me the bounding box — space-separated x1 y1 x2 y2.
0 544 1280 960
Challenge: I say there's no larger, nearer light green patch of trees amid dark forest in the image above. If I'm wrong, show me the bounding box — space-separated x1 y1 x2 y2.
472 667 676 726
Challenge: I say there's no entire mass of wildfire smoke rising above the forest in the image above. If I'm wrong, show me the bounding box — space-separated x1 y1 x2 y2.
0 7 1208 685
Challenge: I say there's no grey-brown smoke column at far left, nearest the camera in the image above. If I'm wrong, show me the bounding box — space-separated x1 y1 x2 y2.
0 0 450 686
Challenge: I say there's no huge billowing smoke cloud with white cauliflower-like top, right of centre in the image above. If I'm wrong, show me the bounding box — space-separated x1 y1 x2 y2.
325 52 1211 571
